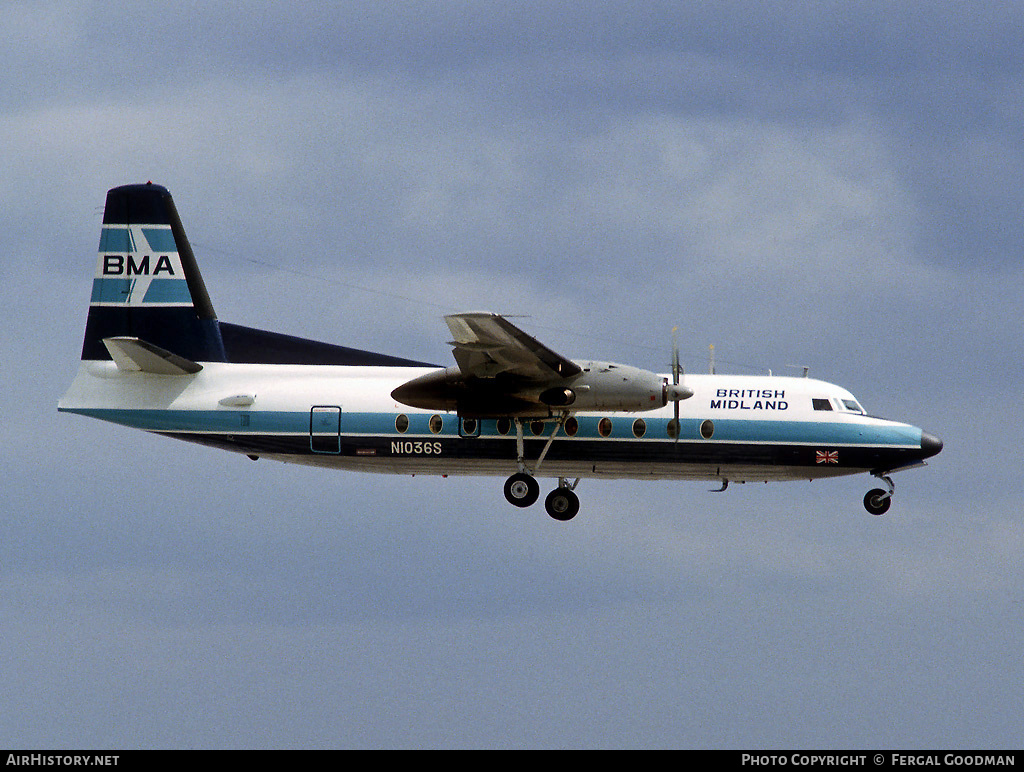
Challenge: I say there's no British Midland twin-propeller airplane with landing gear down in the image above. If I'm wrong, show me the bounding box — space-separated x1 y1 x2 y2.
57 182 942 521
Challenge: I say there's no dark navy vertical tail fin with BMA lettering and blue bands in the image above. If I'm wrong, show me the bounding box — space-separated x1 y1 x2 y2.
82 182 226 361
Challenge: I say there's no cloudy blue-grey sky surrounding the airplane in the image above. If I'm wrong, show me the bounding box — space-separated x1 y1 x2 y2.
0 0 1024 748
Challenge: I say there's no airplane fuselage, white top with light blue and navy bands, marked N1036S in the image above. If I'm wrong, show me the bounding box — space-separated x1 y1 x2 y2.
59 360 922 482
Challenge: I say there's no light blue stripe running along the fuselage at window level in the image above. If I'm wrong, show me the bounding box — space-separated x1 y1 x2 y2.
54 409 921 449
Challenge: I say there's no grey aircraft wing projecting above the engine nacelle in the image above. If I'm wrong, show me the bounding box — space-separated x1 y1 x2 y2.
444 312 582 382
